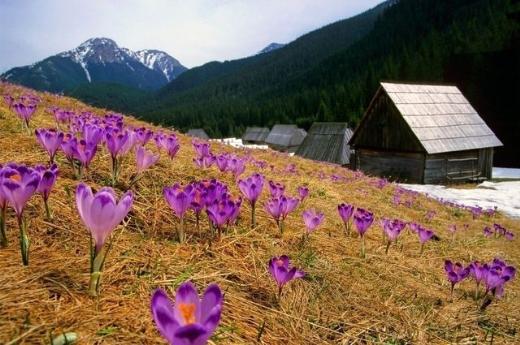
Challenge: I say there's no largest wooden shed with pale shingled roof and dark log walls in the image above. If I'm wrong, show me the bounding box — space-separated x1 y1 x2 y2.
349 83 502 184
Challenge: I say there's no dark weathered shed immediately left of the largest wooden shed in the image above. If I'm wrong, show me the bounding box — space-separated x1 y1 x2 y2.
296 122 353 165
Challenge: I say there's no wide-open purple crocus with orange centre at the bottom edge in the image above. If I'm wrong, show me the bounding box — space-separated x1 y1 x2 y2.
151 282 224 345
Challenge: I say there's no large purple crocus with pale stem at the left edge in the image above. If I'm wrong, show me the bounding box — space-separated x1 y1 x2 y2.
0 164 40 266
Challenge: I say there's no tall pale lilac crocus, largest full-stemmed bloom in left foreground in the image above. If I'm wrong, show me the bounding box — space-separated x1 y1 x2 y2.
76 183 134 296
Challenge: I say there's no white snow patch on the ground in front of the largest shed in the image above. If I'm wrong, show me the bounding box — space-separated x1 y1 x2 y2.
400 181 520 218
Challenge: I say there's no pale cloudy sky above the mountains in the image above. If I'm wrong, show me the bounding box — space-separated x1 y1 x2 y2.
0 0 382 73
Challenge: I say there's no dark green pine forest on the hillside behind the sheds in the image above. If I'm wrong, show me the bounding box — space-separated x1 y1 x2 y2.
61 0 520 166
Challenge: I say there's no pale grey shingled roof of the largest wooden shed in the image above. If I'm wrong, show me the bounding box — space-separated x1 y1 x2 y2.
381 83 502 154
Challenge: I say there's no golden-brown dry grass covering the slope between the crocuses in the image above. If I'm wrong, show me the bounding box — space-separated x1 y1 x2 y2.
0 84 520 345
